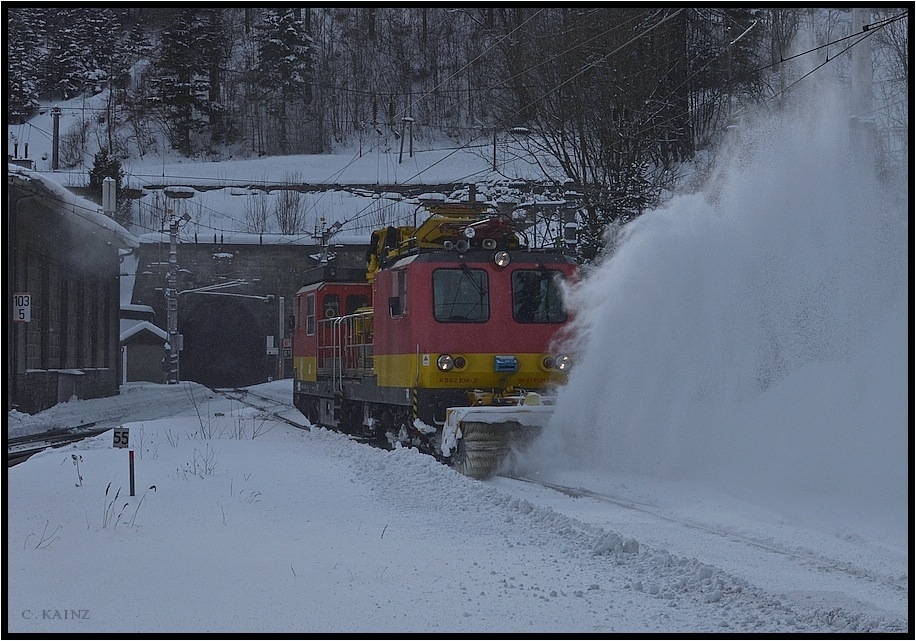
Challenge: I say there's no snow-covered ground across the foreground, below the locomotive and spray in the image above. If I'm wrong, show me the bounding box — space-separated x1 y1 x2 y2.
6 381 909 634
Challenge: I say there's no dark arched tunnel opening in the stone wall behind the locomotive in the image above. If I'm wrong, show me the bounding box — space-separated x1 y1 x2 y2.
179 295 271 387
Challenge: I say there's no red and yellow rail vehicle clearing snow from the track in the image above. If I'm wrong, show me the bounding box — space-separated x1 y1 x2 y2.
293 203 576 478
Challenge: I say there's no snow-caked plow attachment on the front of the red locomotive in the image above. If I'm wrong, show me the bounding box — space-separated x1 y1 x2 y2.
441 405 553 480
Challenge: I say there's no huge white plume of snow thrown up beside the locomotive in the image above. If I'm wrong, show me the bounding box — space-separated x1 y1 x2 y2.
530 75 909 527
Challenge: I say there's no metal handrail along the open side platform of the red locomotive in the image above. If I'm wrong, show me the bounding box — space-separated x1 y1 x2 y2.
318 311 374 392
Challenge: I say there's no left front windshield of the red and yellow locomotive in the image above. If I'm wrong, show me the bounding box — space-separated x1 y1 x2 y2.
433 267 490 323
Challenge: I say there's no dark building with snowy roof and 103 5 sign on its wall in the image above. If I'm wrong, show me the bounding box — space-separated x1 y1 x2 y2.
6 163 139 414
